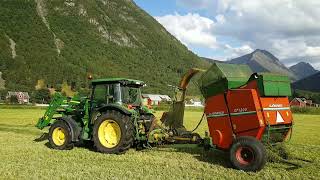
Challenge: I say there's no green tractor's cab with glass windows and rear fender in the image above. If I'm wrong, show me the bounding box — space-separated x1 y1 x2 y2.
88 78 154 132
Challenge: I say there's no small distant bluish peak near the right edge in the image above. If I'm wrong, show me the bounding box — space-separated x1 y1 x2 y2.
289 62 319 79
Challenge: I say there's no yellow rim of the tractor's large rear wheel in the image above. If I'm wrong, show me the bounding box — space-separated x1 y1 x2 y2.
98 119 121 148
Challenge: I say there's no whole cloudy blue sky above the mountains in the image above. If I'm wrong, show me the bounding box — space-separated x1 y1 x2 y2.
134 0 320 70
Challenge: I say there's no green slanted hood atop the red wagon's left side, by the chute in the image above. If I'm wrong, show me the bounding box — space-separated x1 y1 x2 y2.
198 63 252 98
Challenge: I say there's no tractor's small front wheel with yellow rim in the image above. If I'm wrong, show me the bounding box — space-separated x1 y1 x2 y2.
48 120 73 150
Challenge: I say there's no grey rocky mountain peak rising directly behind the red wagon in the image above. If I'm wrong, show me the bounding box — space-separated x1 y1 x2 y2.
228 49 297 80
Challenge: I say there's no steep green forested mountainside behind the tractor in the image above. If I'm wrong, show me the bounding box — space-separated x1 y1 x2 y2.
0 0 209 93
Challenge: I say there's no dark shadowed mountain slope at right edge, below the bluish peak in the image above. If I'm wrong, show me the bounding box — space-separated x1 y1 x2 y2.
292 72 320 92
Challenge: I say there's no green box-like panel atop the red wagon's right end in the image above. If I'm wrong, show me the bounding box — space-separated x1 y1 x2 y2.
258 74 291 96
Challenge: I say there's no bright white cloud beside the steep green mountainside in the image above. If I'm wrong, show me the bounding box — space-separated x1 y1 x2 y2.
155 13 253 58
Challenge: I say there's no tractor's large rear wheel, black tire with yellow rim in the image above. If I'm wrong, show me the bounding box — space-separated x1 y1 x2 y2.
93 111 134 154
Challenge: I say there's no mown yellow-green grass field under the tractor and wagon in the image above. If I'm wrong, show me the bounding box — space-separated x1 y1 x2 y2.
0 109 320 179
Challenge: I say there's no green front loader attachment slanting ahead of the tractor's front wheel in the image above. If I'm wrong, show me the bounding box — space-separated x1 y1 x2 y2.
36 93 66 129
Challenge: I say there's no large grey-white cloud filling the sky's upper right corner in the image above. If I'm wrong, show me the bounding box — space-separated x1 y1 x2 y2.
212 0 320 58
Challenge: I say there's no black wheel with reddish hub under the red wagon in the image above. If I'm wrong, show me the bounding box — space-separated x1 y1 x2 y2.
230 136 267 172
